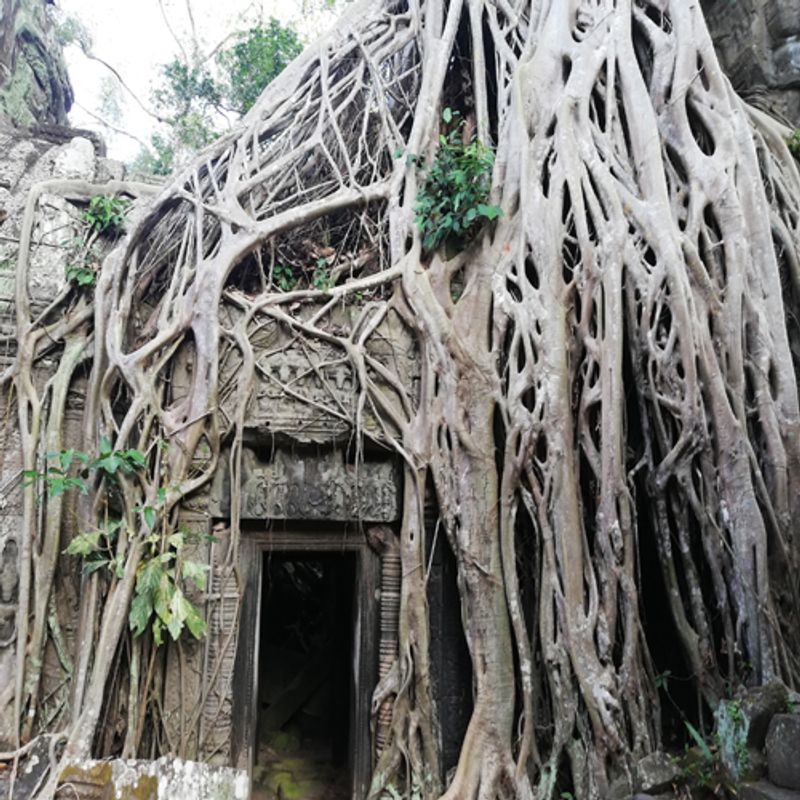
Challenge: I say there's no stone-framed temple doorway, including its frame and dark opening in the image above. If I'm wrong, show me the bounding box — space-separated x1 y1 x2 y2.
232 527 380 800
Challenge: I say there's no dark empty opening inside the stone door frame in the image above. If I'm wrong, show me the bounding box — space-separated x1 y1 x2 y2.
253 551 356 800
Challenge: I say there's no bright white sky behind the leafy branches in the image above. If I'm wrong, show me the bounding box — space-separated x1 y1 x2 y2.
57 0 334 161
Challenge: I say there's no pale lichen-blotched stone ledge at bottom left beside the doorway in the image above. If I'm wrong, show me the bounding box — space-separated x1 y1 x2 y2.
60 758 250 800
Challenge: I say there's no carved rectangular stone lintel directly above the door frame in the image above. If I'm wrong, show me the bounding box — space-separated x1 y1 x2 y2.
213 450 400 522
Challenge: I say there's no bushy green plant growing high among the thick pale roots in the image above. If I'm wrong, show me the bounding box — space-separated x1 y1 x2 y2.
416 108 502 250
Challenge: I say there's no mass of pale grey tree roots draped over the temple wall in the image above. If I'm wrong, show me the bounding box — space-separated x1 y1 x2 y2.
4 0 800 800
